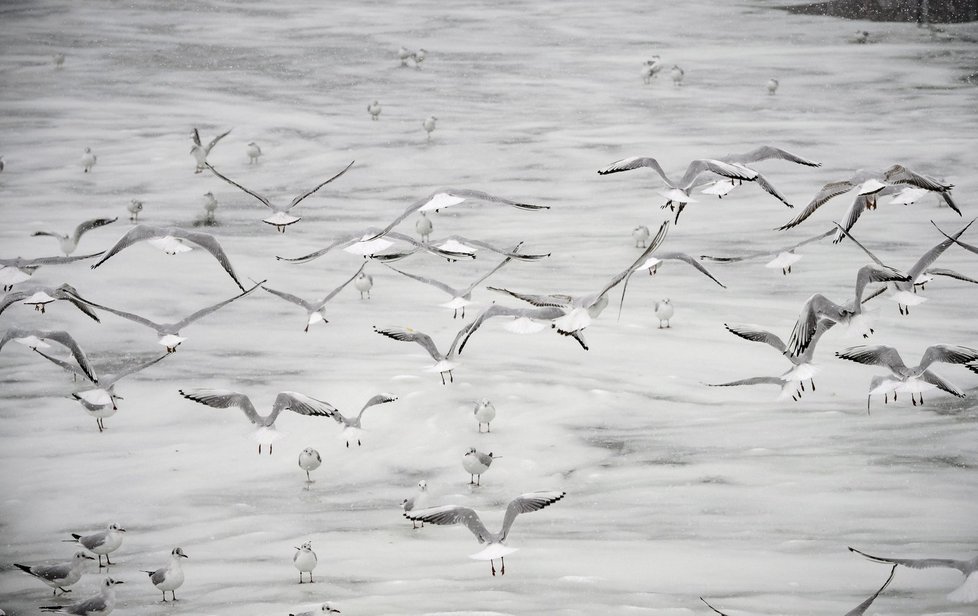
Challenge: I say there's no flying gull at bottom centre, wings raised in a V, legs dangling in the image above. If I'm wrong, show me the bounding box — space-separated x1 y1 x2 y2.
404 491 567 575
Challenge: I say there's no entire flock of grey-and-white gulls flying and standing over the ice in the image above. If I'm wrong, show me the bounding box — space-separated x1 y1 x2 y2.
0 37 978 616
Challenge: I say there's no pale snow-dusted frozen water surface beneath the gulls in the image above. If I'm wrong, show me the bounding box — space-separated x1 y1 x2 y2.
0 0 978 616
